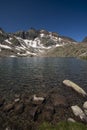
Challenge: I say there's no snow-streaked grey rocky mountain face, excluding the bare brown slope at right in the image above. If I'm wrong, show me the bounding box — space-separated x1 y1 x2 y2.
0 29 74 57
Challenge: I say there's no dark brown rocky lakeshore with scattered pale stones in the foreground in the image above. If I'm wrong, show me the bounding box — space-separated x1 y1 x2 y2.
0 80 87 130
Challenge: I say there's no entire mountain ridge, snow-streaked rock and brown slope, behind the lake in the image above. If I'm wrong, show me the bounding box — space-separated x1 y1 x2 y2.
0 28 87 57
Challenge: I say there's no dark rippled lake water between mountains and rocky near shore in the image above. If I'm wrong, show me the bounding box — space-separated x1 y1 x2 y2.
0 58 87 97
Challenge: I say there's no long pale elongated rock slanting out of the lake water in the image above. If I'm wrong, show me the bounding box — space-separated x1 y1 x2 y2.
63 80 87 96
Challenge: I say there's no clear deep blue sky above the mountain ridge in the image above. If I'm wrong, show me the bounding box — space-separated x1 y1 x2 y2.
0 0 87 41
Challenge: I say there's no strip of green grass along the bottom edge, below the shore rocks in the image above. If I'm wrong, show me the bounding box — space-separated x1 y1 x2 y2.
39 122 87 130
